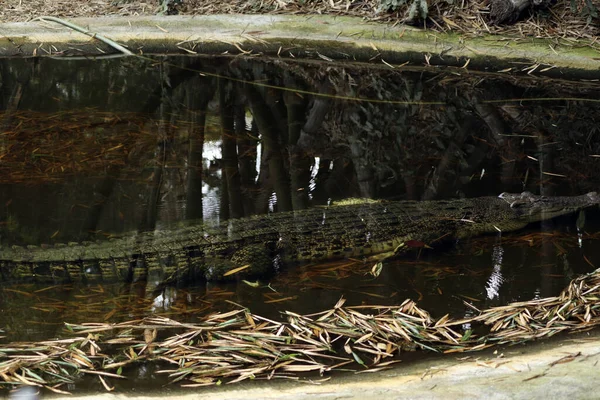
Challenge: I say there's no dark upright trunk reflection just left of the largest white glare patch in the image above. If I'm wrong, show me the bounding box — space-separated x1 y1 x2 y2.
185 77 214 220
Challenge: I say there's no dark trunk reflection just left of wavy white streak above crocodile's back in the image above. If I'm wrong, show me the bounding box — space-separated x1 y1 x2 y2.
284 78 312 210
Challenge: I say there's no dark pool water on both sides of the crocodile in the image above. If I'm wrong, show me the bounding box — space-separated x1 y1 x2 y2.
0 57 600 392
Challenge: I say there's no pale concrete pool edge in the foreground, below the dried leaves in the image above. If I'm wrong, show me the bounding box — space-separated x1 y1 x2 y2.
51 333 600 400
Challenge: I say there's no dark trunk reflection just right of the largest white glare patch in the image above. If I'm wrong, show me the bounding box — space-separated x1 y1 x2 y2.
219 80 244 218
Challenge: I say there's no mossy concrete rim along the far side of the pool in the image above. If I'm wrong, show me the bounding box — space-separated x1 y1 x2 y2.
0 15 600 78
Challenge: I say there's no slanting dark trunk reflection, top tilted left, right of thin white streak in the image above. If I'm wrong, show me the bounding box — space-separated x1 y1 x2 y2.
244 86 292 211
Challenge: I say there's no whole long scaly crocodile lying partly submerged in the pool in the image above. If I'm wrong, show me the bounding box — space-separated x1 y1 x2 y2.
0 192 600 284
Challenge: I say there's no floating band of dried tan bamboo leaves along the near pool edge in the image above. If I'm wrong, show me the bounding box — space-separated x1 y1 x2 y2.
0 269 600 393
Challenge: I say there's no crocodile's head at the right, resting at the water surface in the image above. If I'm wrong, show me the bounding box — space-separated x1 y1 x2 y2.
498 192 600 222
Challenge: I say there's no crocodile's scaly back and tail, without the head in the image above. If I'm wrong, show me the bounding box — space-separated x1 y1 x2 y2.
0 201 478 280
